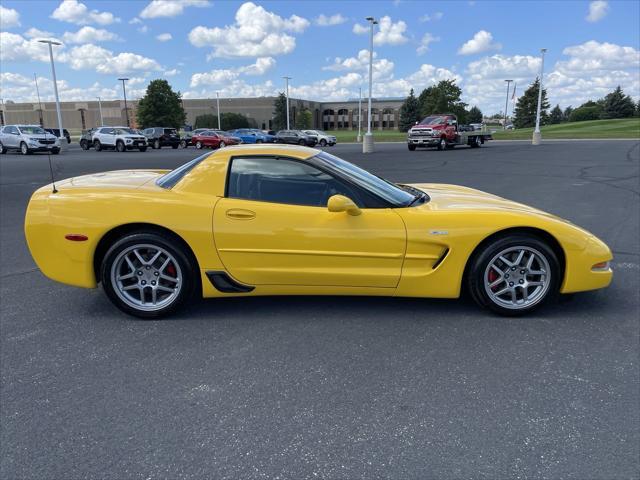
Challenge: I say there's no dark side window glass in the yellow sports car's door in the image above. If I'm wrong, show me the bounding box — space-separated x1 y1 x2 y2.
227 157 362 207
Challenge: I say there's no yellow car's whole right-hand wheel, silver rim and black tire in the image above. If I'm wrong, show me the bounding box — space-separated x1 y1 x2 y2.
466 234 562 316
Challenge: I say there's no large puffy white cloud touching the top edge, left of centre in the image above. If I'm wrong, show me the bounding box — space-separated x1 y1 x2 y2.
189 2 309 57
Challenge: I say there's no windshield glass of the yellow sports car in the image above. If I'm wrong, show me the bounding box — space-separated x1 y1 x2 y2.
314 152 416 207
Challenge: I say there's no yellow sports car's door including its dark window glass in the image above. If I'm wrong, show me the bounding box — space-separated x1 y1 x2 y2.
213 156 406 288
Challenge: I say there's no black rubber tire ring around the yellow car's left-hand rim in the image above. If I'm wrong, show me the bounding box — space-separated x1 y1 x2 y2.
100 232 199 319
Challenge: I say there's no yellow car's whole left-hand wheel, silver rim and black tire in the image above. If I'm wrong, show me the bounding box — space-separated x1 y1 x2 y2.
100 232 197 319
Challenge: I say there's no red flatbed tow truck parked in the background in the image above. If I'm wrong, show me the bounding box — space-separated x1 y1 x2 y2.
407 113 492 151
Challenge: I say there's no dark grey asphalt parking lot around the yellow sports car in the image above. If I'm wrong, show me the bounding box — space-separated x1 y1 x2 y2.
0 141 640 479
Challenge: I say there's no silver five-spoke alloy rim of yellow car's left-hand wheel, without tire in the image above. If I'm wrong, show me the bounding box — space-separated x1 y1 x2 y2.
110 244 183 312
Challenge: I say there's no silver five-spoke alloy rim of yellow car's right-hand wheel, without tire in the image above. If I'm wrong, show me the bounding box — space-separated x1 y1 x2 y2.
483 246 552 310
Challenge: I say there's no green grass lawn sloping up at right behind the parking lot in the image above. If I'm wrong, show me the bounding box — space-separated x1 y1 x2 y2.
493 118 640 140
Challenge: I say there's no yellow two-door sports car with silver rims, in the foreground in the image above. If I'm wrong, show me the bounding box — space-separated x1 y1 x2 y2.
25 145 612 318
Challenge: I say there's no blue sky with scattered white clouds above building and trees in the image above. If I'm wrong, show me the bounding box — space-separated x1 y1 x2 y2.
0 0 640 113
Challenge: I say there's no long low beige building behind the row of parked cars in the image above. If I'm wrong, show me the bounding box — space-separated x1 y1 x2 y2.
0 97 404 131
